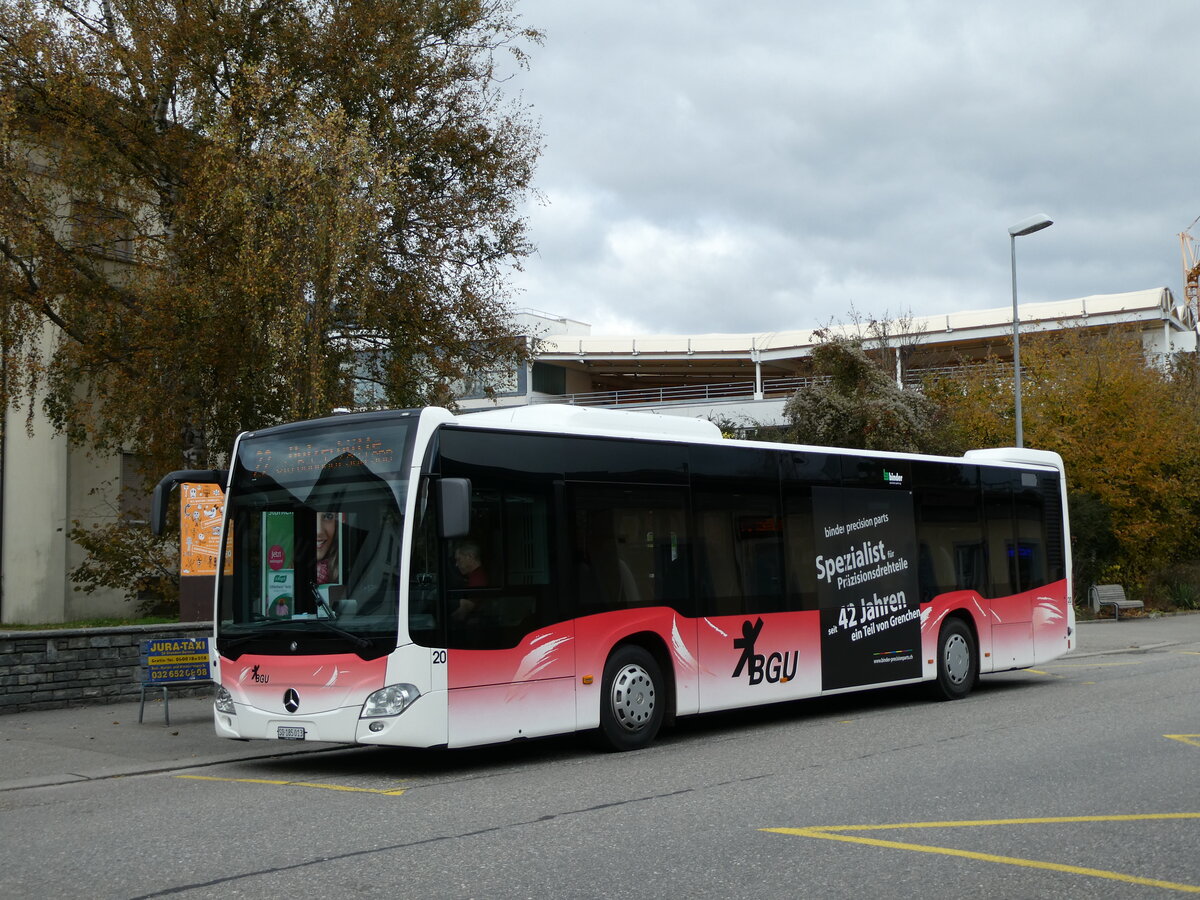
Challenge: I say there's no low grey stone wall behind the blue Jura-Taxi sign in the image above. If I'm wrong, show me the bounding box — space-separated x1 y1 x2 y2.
0 623 212 714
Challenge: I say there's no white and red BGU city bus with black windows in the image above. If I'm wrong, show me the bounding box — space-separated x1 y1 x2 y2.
155 406 1075 750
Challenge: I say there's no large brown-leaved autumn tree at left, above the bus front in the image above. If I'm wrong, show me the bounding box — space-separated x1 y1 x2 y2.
0 0 539 472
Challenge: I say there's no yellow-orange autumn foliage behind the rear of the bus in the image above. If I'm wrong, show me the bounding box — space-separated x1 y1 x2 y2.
926 329 1200 590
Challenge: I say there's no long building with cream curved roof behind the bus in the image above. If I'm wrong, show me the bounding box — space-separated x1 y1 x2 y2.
460 288 1196 425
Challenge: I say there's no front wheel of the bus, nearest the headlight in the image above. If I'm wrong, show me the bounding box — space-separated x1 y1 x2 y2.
599 644 666 751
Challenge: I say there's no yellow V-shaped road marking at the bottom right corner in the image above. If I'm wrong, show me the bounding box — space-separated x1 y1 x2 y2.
762 812 1200 894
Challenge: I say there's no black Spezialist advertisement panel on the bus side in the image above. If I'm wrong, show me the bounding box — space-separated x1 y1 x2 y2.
812 487 922 690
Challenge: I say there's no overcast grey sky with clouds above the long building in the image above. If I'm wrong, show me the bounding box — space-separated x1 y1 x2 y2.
509 0 1200 334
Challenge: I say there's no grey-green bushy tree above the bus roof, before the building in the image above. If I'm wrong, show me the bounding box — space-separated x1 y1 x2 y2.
784 336 952 452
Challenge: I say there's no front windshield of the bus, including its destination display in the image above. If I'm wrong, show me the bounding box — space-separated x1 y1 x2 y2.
217 413 416 659
